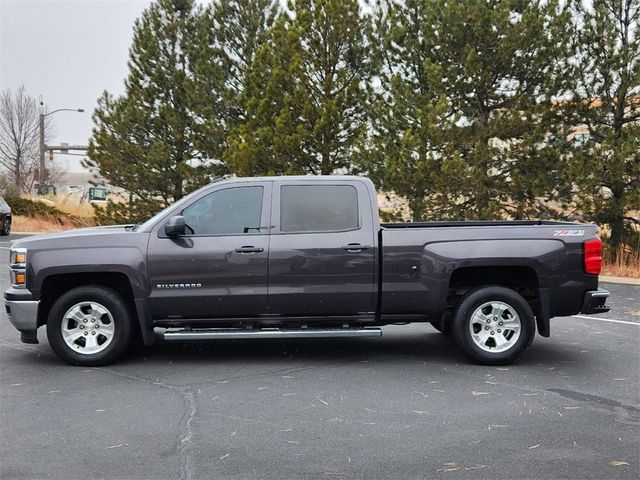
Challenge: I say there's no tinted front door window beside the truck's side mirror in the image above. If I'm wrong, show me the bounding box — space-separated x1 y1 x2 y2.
182 187 263 235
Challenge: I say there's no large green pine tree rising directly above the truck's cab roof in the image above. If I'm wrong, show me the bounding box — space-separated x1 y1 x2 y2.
225 0 371 175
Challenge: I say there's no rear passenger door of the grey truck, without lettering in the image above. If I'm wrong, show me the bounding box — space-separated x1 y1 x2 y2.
269 180 376 317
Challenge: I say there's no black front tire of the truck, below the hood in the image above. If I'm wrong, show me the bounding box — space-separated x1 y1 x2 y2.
47 286 134 367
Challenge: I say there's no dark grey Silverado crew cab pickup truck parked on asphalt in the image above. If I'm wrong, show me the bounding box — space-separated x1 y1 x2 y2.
4 176 609 366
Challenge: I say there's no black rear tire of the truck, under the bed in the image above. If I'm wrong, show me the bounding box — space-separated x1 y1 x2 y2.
451 285 535 365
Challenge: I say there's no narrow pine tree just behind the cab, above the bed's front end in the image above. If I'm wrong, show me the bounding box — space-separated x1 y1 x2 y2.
360 0 448 219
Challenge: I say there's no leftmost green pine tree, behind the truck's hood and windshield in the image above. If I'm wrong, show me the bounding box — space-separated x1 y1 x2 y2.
86 0 216 220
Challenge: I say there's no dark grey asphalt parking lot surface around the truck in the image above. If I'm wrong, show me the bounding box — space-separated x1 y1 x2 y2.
0 236 640 480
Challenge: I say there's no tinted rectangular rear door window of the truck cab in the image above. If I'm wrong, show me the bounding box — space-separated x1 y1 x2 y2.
280 185 359 232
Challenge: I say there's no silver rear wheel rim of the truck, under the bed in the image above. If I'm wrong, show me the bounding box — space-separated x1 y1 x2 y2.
469 301 522 353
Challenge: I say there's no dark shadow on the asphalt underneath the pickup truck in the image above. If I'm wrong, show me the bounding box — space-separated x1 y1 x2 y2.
5 328 586 368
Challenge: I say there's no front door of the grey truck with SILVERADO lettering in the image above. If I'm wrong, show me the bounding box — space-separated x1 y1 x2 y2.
148 182 270 319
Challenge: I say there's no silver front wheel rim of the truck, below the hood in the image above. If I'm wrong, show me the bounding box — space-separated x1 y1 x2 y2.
60 302 115 355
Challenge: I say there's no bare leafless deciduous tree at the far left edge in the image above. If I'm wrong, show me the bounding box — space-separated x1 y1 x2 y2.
0 85 51 193
